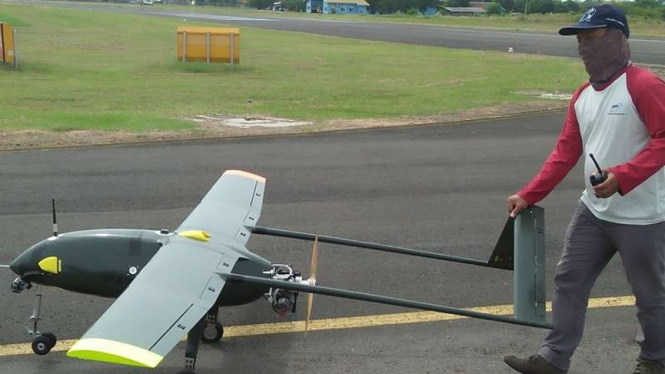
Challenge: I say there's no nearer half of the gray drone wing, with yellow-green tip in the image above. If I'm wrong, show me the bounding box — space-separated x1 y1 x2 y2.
67 237 237 368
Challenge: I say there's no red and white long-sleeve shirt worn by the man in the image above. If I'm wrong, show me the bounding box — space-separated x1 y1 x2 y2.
518 64 665 225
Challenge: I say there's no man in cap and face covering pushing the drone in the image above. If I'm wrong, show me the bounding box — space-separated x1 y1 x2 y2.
505 5 665 374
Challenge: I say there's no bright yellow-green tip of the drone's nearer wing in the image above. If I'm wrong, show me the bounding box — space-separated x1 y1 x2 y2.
67 338 164 369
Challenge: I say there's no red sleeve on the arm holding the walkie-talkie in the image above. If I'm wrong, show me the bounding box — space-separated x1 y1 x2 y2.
610 67 665 195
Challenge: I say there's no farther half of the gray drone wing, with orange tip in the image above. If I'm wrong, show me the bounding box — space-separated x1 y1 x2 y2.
176 170 266 246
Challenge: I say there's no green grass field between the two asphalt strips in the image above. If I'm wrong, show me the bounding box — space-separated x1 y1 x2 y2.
0 5 586 131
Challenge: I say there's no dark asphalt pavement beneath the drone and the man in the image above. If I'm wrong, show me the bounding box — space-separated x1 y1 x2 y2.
0 113 638 374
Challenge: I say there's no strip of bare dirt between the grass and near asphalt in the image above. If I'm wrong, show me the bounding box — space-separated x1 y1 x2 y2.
0 101 567 151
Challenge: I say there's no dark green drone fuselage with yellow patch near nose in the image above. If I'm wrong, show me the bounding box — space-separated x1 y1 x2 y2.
10 229 271 306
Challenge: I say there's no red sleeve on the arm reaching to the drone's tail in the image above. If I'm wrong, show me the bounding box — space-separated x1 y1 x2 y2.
517 83 589 205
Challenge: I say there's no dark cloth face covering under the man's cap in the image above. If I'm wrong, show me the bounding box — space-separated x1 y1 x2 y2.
577 28 630 84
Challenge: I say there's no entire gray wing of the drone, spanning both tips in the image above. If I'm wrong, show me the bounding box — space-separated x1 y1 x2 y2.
67 170 265 368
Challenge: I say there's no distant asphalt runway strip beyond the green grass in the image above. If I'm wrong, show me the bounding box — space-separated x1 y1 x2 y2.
7 0 665 65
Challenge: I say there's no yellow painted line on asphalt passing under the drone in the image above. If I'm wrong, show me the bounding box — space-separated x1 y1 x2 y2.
0 296 635 357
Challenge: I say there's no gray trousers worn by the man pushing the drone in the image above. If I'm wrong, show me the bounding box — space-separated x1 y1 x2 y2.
538 202 665 370
